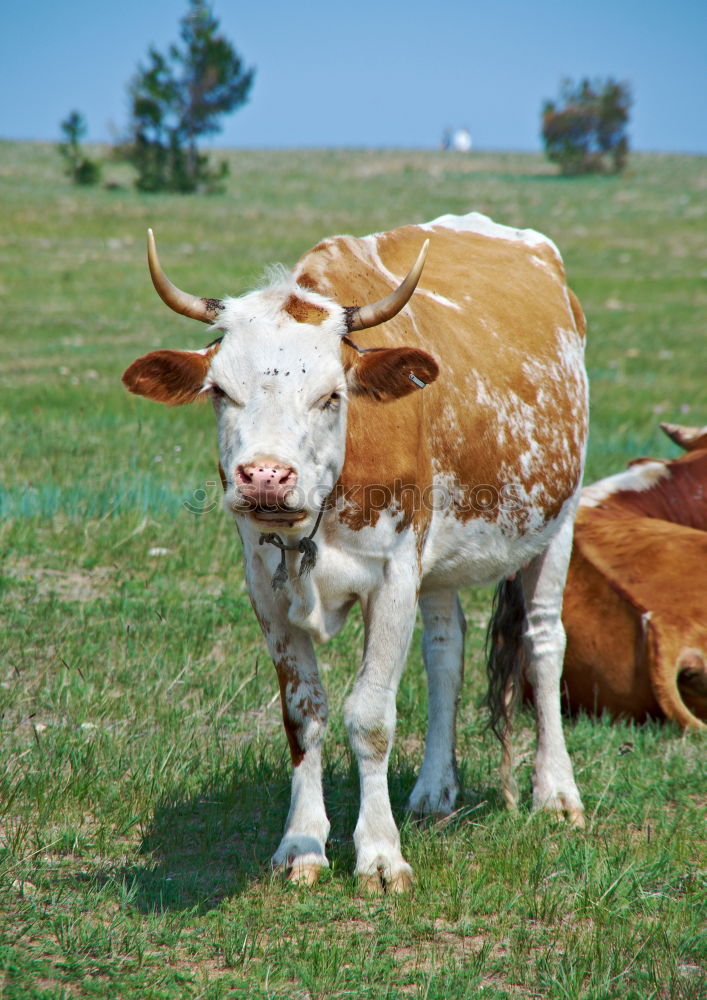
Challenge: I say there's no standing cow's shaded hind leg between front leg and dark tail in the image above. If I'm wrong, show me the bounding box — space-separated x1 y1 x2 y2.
408 590 466 816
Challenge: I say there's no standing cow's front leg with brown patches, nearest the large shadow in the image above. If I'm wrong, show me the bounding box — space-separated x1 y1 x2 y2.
246 567 329 885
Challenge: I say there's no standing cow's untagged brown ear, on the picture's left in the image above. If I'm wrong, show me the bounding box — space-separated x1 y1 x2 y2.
123 350 215 406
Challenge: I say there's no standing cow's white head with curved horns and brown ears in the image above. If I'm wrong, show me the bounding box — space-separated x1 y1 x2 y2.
123 230 438 533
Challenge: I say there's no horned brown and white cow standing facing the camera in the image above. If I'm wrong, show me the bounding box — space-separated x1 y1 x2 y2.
123 214 587 891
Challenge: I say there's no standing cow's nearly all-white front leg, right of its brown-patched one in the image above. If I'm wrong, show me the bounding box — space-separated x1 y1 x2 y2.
344 563 417 892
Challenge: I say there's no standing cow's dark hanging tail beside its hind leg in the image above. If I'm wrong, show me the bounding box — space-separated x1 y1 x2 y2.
486 574 526 808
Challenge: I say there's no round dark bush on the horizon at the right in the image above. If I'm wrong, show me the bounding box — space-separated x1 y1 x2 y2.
542 77 632 174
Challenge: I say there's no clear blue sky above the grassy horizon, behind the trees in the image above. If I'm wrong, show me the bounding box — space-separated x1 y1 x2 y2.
0 0 707 153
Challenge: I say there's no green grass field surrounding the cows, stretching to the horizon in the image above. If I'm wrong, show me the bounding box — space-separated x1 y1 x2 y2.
0 143 707 1000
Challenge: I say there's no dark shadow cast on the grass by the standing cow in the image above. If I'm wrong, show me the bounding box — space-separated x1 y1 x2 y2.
113 748 500 913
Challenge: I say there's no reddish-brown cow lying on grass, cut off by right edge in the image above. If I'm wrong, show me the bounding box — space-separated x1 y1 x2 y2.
563 424 707 727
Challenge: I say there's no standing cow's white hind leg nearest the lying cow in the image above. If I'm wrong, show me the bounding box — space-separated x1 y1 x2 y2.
521 494 584 826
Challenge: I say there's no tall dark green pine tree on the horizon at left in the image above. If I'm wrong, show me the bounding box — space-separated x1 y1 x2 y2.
127 0 255 192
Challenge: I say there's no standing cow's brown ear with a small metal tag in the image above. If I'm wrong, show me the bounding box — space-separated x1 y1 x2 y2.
347 347 439 402
